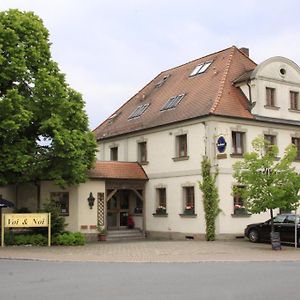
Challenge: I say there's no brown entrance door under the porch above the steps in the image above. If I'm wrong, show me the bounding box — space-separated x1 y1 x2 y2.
107 191 129 230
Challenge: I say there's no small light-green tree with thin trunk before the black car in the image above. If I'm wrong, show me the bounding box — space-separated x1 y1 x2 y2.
233 138 300 232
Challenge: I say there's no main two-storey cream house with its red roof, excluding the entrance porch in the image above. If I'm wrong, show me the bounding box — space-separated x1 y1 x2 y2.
94 47 300 238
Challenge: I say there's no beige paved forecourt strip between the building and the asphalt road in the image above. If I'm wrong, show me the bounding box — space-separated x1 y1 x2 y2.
0 239 300 262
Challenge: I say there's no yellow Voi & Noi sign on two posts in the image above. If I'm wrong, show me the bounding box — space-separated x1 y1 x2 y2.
1 213 51 247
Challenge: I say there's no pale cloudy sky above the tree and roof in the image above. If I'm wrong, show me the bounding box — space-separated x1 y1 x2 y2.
0 0 300 129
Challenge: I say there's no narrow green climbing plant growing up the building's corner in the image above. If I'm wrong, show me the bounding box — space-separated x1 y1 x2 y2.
199 156 221 241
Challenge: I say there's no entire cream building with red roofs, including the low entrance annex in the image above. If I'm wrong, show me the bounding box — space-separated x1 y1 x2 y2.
0 46 300 238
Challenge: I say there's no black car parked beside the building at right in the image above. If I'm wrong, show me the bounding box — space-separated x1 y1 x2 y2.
245 214 300 245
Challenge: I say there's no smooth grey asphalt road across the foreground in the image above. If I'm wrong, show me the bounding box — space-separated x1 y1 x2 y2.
0 260 300 300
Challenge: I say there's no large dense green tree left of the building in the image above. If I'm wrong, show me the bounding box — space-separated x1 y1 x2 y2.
0 10 96 202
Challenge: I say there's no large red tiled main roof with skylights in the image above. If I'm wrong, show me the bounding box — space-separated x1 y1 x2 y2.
94 46 256 139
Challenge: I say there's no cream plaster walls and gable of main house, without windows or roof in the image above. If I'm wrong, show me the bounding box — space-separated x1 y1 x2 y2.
98 57 300 238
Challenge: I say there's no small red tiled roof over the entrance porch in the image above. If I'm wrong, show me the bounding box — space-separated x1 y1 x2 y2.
88 161 148 180
